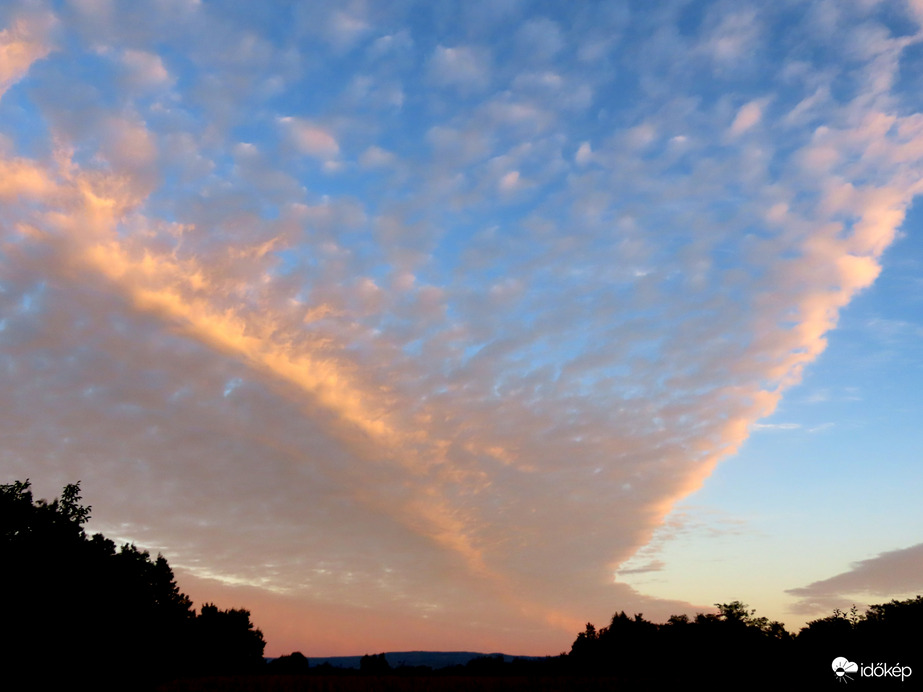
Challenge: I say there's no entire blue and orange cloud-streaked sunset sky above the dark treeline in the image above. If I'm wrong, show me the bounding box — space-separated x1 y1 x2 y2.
0 0 923 657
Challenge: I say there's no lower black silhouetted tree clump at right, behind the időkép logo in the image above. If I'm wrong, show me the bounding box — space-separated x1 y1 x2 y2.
568 596 923 689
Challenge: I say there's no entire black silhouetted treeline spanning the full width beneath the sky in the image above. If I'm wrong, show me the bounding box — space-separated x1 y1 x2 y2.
0 481 923 690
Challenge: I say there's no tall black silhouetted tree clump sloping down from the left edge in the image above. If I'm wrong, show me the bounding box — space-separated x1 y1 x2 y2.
0 481 265 690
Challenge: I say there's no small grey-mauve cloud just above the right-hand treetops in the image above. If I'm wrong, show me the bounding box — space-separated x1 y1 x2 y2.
786 544 923 615
